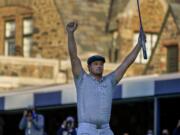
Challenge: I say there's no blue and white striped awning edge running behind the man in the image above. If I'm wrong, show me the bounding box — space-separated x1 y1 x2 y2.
0 73 180 111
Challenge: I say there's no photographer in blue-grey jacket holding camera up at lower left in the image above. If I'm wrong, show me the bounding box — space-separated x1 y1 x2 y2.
19 107 44 135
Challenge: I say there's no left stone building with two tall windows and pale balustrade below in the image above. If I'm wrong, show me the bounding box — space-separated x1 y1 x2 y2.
0 0 112 89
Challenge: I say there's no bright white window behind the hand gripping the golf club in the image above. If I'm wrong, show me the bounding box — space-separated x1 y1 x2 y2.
133 33 157 64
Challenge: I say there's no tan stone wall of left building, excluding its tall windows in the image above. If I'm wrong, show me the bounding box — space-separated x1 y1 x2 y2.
0 0 115 89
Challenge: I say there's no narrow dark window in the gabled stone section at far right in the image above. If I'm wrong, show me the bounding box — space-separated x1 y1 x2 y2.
167 45 178 73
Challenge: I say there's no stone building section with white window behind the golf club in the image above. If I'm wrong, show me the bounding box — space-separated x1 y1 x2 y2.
107 0 180 76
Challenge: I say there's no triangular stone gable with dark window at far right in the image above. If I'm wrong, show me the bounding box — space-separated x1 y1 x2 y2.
144 3 180 74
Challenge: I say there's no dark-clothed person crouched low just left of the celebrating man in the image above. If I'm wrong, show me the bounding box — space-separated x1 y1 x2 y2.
57 116 76 135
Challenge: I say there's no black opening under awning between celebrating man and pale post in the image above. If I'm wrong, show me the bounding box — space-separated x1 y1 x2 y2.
111 100 153 135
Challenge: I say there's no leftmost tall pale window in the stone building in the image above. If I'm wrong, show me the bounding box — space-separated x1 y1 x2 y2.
5 20 16 56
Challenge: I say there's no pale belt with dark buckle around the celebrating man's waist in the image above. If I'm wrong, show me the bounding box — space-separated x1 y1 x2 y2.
79 122 109 129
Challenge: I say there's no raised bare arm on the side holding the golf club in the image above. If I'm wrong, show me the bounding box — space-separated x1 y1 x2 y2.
115 33 141 82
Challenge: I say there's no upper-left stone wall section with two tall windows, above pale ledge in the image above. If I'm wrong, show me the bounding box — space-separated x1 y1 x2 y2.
0 0 67 59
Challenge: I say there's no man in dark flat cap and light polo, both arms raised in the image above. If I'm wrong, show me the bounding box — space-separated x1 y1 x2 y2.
66 22 141 135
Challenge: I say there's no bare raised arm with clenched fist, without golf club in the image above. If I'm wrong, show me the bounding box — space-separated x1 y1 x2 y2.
66 22 83 77
